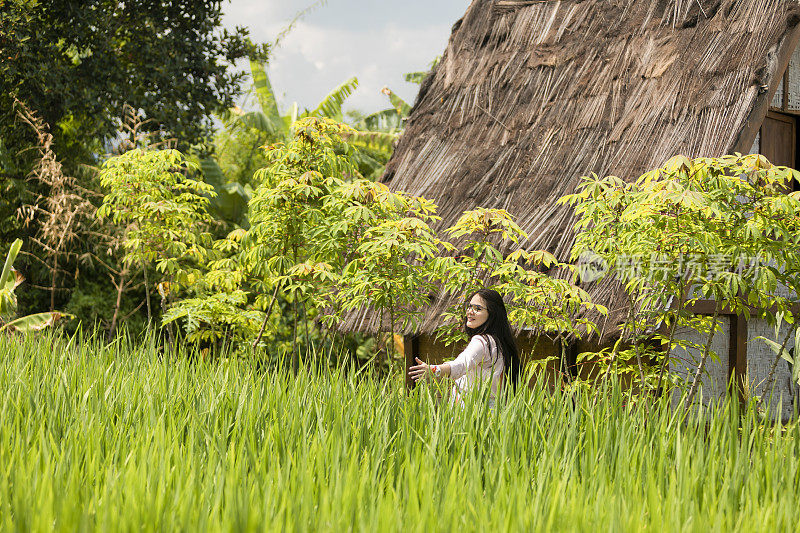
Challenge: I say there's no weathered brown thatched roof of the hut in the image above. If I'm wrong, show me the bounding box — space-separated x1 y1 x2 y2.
343 0 800 333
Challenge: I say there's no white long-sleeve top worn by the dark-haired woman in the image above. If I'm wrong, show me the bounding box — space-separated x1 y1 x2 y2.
449 335 505 405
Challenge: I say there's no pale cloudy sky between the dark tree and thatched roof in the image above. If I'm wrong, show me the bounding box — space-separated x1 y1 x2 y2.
223 0 470 113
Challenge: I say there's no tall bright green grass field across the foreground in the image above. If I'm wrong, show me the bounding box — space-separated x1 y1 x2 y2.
0 336 800 531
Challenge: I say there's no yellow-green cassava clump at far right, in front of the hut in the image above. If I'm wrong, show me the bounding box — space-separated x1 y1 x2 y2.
561 154 800 408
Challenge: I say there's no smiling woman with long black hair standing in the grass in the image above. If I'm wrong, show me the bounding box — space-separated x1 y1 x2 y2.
409 289 519 405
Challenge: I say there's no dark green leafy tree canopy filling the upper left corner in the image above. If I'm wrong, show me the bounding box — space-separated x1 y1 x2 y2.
0 0 266 155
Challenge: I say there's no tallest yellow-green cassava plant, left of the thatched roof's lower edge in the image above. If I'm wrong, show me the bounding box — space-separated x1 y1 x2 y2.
241 117 356 368
